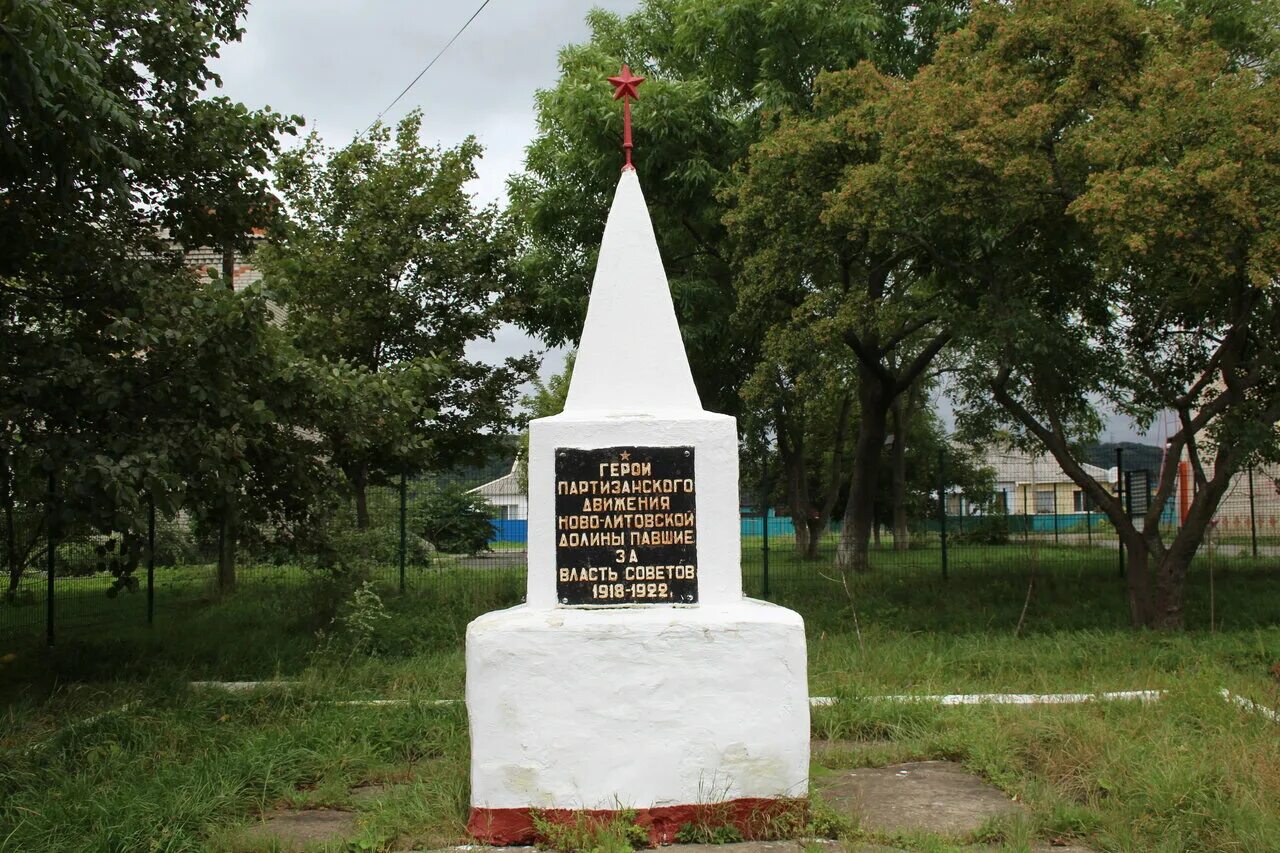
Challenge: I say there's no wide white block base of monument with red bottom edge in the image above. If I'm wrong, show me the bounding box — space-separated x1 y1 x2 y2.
467 599 809 844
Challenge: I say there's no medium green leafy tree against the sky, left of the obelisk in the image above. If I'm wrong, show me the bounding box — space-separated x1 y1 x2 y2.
259 113 531 528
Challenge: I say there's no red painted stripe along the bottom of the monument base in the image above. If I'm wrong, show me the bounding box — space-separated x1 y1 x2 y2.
467 797 809 847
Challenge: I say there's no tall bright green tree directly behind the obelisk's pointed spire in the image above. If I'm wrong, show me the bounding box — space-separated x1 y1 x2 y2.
508 0 963 414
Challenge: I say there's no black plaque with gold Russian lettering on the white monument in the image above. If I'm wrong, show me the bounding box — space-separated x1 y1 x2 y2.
556 447 698 607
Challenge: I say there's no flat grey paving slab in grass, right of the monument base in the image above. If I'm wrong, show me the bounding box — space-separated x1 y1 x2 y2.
817 761 1021 835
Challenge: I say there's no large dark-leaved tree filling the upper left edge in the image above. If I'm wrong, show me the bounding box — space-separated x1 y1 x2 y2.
0 0 303 588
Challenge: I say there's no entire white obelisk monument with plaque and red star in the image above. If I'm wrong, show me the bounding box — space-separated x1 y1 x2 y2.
466 69 809 844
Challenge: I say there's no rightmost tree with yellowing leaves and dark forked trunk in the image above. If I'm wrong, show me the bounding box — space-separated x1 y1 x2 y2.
846 0 1280 628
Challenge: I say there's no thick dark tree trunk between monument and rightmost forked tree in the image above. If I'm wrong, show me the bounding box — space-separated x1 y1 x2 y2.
836 368 888 573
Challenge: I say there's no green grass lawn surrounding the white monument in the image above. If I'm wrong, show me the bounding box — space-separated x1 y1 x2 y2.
0 543 1280 852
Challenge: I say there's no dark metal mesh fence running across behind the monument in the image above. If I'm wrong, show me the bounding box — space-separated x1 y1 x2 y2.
0 455 1280 643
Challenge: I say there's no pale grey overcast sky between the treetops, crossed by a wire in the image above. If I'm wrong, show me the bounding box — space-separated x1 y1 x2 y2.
214 0 1156 441
